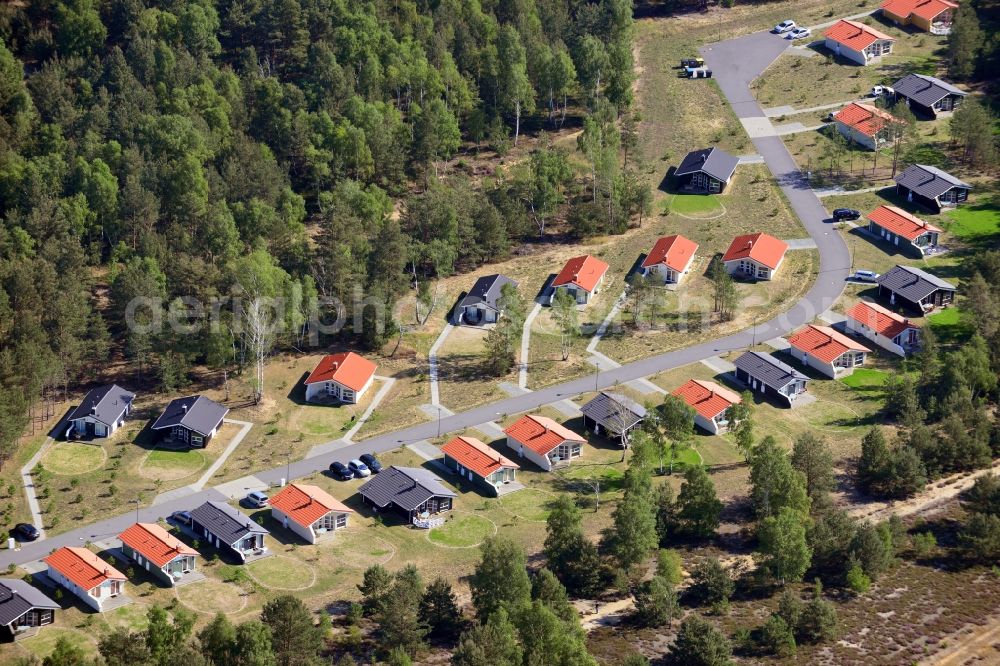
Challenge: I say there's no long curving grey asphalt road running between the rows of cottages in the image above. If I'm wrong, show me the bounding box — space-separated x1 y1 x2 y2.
0 33 851 567
